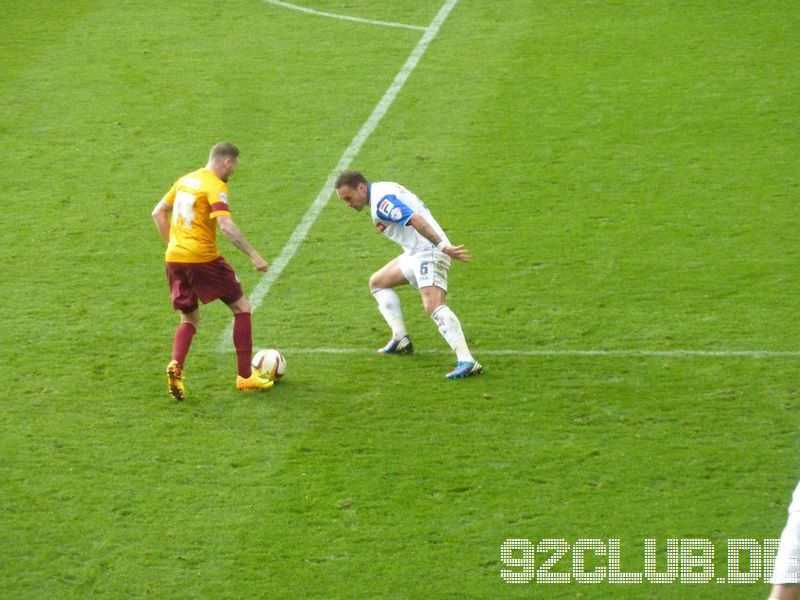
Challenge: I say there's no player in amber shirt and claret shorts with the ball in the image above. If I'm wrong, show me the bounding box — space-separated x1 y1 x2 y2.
152 142 272 400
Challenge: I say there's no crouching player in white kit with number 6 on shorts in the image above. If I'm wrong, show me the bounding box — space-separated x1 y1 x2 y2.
335 171 483 379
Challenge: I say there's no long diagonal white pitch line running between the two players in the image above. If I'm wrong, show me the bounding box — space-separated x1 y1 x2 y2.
219 0 458 350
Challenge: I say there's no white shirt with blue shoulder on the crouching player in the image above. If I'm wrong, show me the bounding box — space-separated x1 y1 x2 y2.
369 181 450 254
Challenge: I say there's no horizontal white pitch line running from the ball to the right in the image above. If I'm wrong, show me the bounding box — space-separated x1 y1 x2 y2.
272 348 800 358
